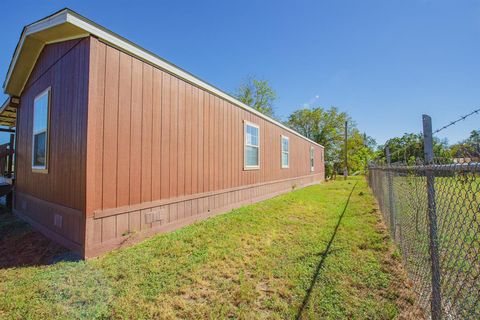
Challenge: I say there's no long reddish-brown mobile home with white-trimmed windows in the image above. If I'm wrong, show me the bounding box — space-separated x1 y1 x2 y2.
0 9 324 257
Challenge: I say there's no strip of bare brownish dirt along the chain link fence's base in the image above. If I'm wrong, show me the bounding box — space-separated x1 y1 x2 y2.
372 206 427 320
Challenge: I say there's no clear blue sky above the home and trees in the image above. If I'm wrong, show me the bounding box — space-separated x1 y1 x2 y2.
0 0 480 144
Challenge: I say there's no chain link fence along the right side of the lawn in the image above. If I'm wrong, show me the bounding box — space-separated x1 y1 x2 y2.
368 161 480 319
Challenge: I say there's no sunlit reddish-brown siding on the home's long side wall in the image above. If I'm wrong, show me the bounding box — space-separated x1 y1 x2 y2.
87 38 323 215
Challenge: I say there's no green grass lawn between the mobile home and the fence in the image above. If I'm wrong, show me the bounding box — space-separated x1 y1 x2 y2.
0 178 420 319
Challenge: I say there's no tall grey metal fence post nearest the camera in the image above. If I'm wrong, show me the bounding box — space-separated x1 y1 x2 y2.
422 114 442 320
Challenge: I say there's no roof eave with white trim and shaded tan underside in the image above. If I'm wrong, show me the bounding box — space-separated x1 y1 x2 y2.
3 9 323 148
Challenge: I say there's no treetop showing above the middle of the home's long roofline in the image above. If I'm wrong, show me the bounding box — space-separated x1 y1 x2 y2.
234 77 277 118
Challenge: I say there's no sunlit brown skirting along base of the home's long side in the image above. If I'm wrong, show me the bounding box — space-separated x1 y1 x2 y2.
85 173 324 258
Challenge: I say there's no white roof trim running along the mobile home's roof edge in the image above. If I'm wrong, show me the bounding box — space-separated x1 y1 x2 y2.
3 9 323 148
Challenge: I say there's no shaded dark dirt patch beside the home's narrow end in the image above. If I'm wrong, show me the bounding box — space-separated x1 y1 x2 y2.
0 208 68 269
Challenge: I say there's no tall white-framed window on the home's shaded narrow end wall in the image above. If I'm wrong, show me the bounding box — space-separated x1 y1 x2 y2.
32 88 50 171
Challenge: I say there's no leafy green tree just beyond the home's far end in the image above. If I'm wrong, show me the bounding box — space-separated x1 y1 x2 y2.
285 107 375 176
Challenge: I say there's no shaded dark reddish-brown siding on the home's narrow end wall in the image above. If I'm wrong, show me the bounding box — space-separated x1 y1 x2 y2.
15 38 90 249
